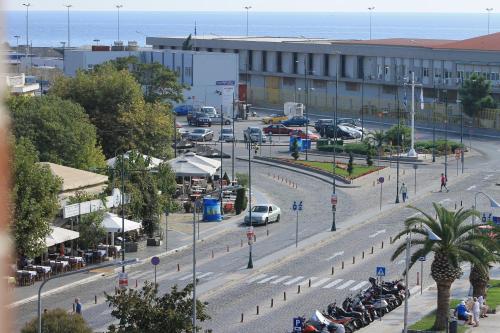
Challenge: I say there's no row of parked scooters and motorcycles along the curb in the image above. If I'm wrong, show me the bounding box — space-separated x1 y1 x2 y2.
294 277 410 333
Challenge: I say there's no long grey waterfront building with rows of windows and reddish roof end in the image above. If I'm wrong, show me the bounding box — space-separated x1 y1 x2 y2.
146 33 500 128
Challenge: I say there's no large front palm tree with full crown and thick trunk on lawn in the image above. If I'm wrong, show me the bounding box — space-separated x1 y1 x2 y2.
391 203 491 330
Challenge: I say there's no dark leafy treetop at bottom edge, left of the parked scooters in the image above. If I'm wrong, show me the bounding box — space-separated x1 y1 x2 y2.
106 282 210 333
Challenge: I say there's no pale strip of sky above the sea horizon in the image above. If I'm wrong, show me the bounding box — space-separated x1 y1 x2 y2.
0 0 500 13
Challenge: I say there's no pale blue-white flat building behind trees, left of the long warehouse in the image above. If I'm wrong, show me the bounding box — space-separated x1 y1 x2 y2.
64 49 239 113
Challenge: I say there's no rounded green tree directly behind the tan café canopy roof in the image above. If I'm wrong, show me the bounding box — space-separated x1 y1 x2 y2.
7 96 105 169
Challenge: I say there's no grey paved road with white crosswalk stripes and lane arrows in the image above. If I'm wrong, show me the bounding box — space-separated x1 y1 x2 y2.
8 113 500 332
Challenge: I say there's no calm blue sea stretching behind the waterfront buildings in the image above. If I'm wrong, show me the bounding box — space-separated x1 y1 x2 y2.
5 11 500 46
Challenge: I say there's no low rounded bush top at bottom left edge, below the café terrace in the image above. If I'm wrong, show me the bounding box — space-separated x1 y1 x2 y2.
21 309 93 333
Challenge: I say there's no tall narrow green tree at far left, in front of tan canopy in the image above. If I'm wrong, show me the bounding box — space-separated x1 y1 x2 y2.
12 139 62 257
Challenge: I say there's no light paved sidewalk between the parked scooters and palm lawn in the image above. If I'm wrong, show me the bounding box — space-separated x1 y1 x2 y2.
359 265 500 333
